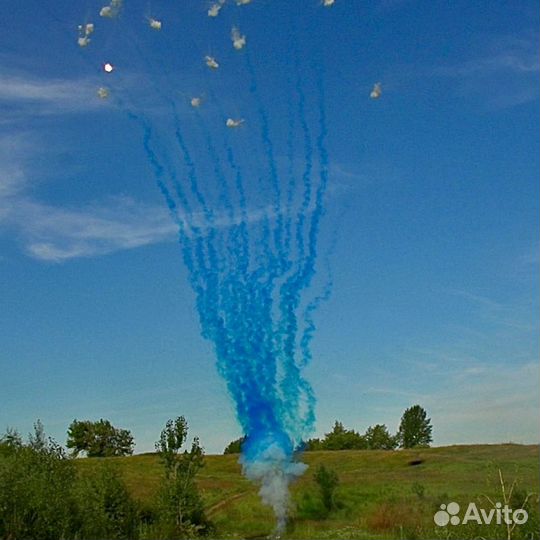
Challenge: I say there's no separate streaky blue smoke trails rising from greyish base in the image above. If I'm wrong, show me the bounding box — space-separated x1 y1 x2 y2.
139 54 330 530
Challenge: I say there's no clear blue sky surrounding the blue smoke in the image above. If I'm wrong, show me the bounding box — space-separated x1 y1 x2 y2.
0 0 540 452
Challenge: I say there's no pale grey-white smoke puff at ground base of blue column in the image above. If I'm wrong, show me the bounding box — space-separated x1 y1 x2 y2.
240 443 307 534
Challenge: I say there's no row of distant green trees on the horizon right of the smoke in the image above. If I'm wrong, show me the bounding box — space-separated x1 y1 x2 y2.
223 405 433 454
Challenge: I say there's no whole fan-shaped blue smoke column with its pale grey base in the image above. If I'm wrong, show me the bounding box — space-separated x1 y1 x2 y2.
87 1 331 532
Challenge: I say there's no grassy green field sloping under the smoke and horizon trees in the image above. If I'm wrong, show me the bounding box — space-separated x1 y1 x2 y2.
78 444 540 539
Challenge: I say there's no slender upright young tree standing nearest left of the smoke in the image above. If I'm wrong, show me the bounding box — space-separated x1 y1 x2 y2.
156 416 210 539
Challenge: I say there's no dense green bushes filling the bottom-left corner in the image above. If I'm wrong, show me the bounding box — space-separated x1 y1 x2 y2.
0 421 139 540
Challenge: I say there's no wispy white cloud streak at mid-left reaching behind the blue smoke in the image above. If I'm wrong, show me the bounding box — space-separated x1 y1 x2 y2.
0 134 282 262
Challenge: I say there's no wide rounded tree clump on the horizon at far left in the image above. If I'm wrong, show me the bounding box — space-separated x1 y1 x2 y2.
66 419 135 457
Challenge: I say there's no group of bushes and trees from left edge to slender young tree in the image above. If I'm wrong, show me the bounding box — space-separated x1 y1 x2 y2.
0 416 209 540
